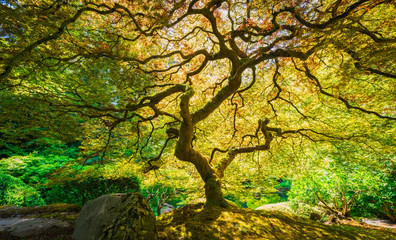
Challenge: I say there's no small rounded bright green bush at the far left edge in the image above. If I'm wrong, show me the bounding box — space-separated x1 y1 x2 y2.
0 173 44 206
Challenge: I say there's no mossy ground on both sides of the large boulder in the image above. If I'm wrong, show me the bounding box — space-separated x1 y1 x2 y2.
0 203 396 240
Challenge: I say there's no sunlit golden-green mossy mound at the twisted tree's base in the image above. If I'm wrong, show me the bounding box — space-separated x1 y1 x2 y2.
157 203 396 240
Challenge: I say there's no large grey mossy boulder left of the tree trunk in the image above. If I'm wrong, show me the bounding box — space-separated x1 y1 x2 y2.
73 193 158 240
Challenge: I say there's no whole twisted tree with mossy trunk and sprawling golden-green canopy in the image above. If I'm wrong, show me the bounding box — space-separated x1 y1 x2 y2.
0 0 396 205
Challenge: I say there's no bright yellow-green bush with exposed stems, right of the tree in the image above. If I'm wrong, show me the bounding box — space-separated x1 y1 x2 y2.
290 159 389 217
